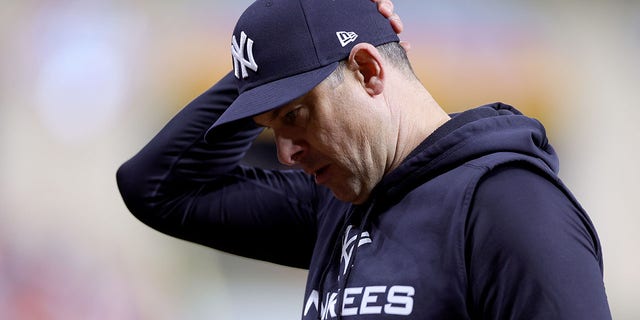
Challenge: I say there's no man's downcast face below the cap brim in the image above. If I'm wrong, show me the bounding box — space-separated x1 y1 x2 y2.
254 74 390 204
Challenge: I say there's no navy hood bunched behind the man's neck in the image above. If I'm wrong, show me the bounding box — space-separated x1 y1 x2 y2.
372 102 559 208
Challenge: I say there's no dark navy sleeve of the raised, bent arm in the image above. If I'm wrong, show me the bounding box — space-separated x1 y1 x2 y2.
116 74 316 268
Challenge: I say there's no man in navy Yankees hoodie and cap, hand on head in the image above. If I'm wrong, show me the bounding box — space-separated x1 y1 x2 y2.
118 0 610 319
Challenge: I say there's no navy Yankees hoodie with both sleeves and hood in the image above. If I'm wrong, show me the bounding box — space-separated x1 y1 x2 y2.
117 75 611 320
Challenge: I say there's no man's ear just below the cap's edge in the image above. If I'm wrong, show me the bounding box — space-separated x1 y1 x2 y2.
348 43 385 96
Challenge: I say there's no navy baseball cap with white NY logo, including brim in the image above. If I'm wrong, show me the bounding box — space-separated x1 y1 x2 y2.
205 0 399 138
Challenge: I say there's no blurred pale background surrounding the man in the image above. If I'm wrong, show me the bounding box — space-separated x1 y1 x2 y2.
0 0 640 320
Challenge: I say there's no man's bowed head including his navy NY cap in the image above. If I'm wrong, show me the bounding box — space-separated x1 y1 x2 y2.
207 0 432 203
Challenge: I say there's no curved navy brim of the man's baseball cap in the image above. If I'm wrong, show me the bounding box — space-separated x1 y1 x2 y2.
205 62 338 141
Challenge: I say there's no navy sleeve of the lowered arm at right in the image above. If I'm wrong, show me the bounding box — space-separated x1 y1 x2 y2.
466 167 611 320
